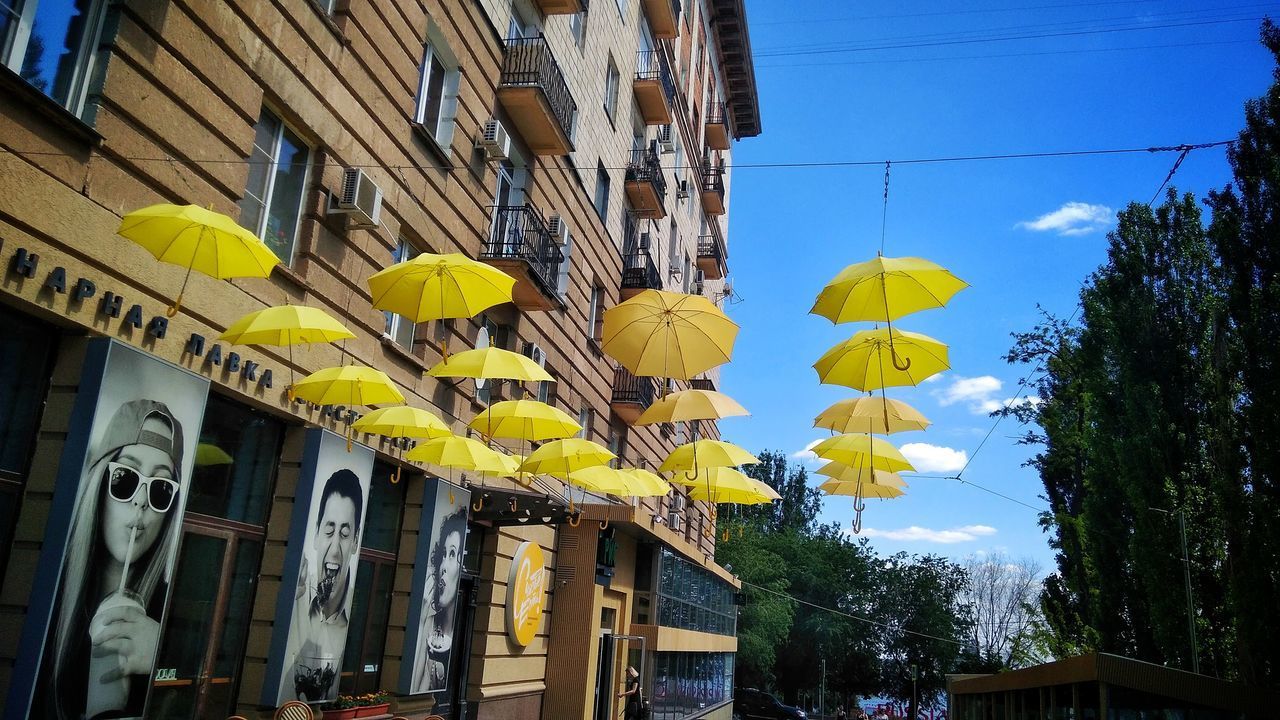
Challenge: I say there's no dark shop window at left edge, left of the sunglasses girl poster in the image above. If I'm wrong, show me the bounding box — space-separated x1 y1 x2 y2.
0 307 54 580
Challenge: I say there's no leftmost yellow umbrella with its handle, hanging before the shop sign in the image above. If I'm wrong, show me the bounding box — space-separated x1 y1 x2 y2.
115 202 280 318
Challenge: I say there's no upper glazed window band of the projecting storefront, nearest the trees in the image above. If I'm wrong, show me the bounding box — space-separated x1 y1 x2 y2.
658 548 737 635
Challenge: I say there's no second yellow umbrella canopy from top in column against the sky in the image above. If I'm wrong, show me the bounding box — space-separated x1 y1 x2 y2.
813 328 951 392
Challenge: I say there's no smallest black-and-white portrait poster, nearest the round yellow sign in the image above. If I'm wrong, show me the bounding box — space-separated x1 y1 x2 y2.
399 478 471 694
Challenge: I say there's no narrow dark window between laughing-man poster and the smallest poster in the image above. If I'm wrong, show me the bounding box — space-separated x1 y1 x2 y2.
338 462 406 694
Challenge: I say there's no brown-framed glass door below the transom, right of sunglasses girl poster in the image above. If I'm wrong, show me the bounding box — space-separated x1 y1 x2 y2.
147 516 262 720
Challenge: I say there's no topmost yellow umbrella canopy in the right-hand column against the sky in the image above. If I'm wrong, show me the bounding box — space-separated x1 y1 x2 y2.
809 256 969 323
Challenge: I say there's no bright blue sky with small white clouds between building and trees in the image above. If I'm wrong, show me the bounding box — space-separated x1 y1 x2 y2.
722 0 1280 570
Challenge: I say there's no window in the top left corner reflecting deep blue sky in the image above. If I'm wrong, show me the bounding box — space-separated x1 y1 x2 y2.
0 0 108 117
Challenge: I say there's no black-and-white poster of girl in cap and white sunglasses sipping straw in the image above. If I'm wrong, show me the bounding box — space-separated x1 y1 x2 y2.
31 342 209 719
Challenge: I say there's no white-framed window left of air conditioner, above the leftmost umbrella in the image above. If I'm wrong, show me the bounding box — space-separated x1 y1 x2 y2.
239 108 311 265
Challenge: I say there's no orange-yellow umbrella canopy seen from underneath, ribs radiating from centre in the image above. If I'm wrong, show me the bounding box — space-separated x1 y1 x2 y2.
602 290 737 380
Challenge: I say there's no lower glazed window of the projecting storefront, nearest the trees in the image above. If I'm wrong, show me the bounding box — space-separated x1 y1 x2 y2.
649 652 733 720
